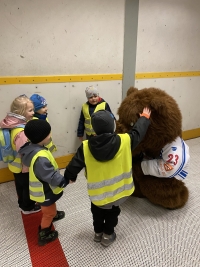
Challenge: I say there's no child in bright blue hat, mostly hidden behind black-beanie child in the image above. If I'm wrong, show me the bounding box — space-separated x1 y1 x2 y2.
30 94 57 153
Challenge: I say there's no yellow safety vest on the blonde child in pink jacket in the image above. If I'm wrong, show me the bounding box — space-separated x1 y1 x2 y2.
8 128 24 173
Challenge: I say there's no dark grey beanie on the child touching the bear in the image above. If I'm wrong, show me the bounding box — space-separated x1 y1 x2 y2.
91 110 114 135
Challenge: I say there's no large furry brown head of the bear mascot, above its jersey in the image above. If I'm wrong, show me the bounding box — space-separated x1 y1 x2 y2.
116 87 182 159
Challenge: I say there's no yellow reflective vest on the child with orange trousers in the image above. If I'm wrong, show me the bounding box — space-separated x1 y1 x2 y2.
29 150 63 203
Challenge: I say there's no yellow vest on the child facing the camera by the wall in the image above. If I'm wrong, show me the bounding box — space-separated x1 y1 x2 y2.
82 102 106 135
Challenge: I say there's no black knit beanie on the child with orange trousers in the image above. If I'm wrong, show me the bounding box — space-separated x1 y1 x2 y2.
24 119 51 144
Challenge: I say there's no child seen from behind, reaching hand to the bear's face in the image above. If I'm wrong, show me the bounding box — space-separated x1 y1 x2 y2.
64 108 151 247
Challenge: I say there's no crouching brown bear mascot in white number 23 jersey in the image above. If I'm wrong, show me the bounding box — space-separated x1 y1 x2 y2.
116 87 189 209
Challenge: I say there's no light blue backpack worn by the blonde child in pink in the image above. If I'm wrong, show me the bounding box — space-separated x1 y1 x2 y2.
0 124 25 163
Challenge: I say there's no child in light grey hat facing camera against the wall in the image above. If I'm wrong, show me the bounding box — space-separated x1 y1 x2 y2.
77 86 114 141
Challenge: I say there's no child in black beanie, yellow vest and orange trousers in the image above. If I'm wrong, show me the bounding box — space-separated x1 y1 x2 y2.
19 120 69 246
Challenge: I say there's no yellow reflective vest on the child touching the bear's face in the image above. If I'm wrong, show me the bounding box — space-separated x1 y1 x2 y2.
83 134 135 206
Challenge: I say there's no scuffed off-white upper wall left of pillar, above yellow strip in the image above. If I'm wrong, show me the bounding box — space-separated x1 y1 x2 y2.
0 0 124 76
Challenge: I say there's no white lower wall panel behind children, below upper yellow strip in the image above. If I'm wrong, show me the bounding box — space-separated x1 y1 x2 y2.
0 81 122 167
